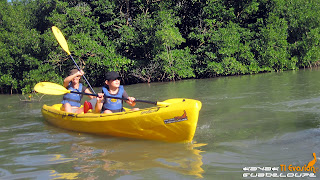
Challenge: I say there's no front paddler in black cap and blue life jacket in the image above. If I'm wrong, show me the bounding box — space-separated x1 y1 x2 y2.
95 71 138 113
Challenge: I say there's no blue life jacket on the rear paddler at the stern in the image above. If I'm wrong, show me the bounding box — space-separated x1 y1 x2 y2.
61 82 83 107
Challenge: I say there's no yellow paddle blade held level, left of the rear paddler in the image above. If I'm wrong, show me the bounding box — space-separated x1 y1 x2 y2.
34 82 70 95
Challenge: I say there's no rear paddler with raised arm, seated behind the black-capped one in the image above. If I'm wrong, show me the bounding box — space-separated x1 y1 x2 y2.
61 69 95 113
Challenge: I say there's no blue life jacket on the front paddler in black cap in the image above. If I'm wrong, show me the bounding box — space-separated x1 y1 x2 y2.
102 85 124 110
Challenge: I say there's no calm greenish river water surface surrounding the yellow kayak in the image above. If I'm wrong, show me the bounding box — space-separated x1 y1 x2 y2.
0 69 320 180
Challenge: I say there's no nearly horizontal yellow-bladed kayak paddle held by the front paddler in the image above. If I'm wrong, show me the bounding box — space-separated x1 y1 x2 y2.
34 82 170 106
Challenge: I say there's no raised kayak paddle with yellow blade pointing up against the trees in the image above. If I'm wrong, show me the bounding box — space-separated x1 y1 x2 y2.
51 26 95 93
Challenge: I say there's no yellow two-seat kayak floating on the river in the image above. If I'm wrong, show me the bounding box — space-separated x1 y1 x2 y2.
42 98 202 142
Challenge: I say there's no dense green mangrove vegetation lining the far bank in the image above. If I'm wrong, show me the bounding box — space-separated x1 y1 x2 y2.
0 0 320 93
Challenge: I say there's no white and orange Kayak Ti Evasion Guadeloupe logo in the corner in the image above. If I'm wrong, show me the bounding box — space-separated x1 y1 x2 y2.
242 153 319 178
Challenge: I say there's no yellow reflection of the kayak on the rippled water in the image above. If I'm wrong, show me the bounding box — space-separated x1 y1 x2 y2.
71 140 205 178
